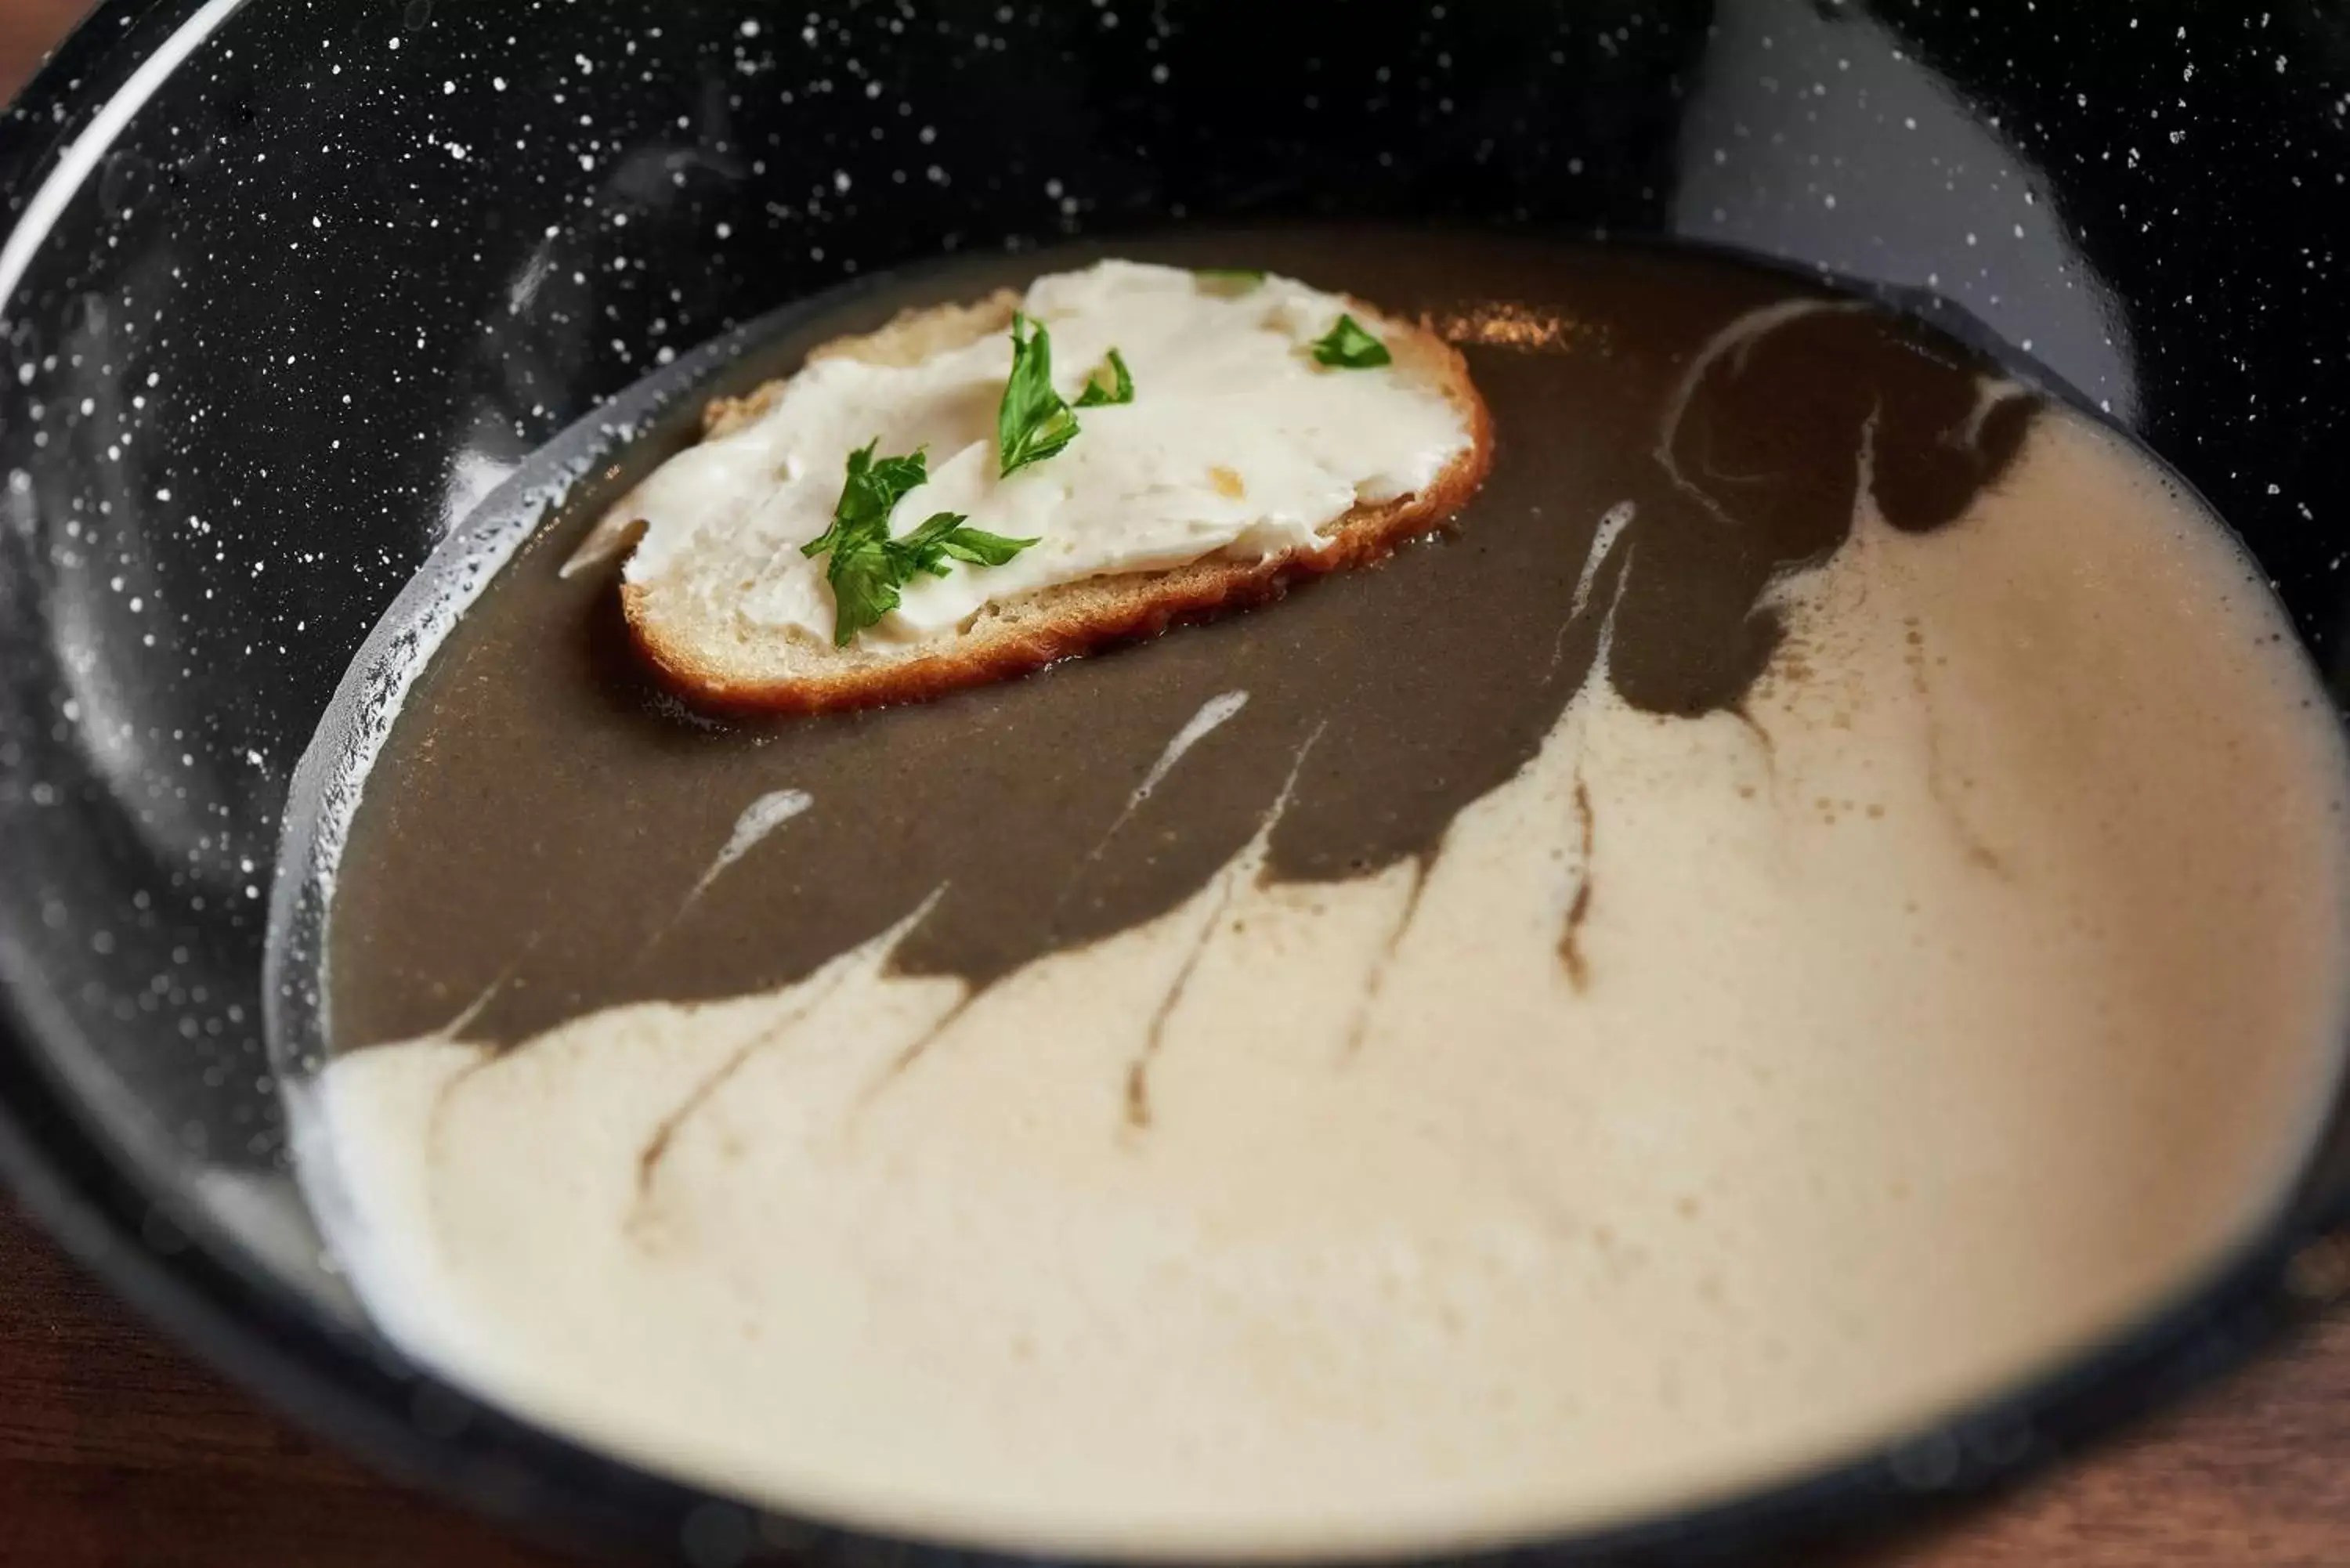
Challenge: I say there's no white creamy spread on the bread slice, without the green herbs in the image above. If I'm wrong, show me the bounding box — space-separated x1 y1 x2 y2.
625 261 1473 641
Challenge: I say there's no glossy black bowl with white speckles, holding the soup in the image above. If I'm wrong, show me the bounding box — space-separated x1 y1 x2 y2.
0 0 2350 1566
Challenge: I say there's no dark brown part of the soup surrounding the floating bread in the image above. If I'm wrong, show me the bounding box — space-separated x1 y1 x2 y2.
331 228 2037 1044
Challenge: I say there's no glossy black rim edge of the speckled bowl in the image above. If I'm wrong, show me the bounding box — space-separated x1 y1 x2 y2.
0 0 2350 1568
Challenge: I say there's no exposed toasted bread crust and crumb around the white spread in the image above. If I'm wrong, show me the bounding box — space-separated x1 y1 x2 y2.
599 289 1492 712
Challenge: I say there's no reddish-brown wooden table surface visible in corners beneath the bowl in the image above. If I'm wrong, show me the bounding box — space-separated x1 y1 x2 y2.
0 0 2350 1568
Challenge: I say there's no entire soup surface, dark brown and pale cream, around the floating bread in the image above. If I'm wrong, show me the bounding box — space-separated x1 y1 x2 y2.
296 228 2350 1554
